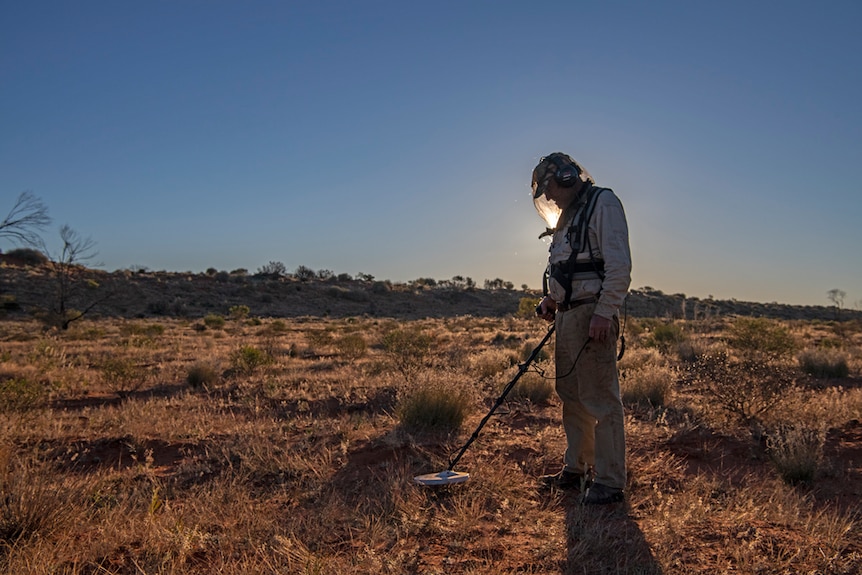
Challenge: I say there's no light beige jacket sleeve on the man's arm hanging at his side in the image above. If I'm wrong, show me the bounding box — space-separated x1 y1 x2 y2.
589 192 632 319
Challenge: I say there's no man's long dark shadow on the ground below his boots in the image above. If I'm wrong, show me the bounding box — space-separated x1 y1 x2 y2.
562 496 662 575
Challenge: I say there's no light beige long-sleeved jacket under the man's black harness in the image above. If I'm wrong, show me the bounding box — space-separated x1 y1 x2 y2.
548 189 632 319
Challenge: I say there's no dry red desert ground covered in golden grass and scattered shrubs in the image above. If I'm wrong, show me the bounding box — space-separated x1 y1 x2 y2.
0 268 862 575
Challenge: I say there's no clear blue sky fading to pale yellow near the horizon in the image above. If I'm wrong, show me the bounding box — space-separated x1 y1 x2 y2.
0 0 862 307
